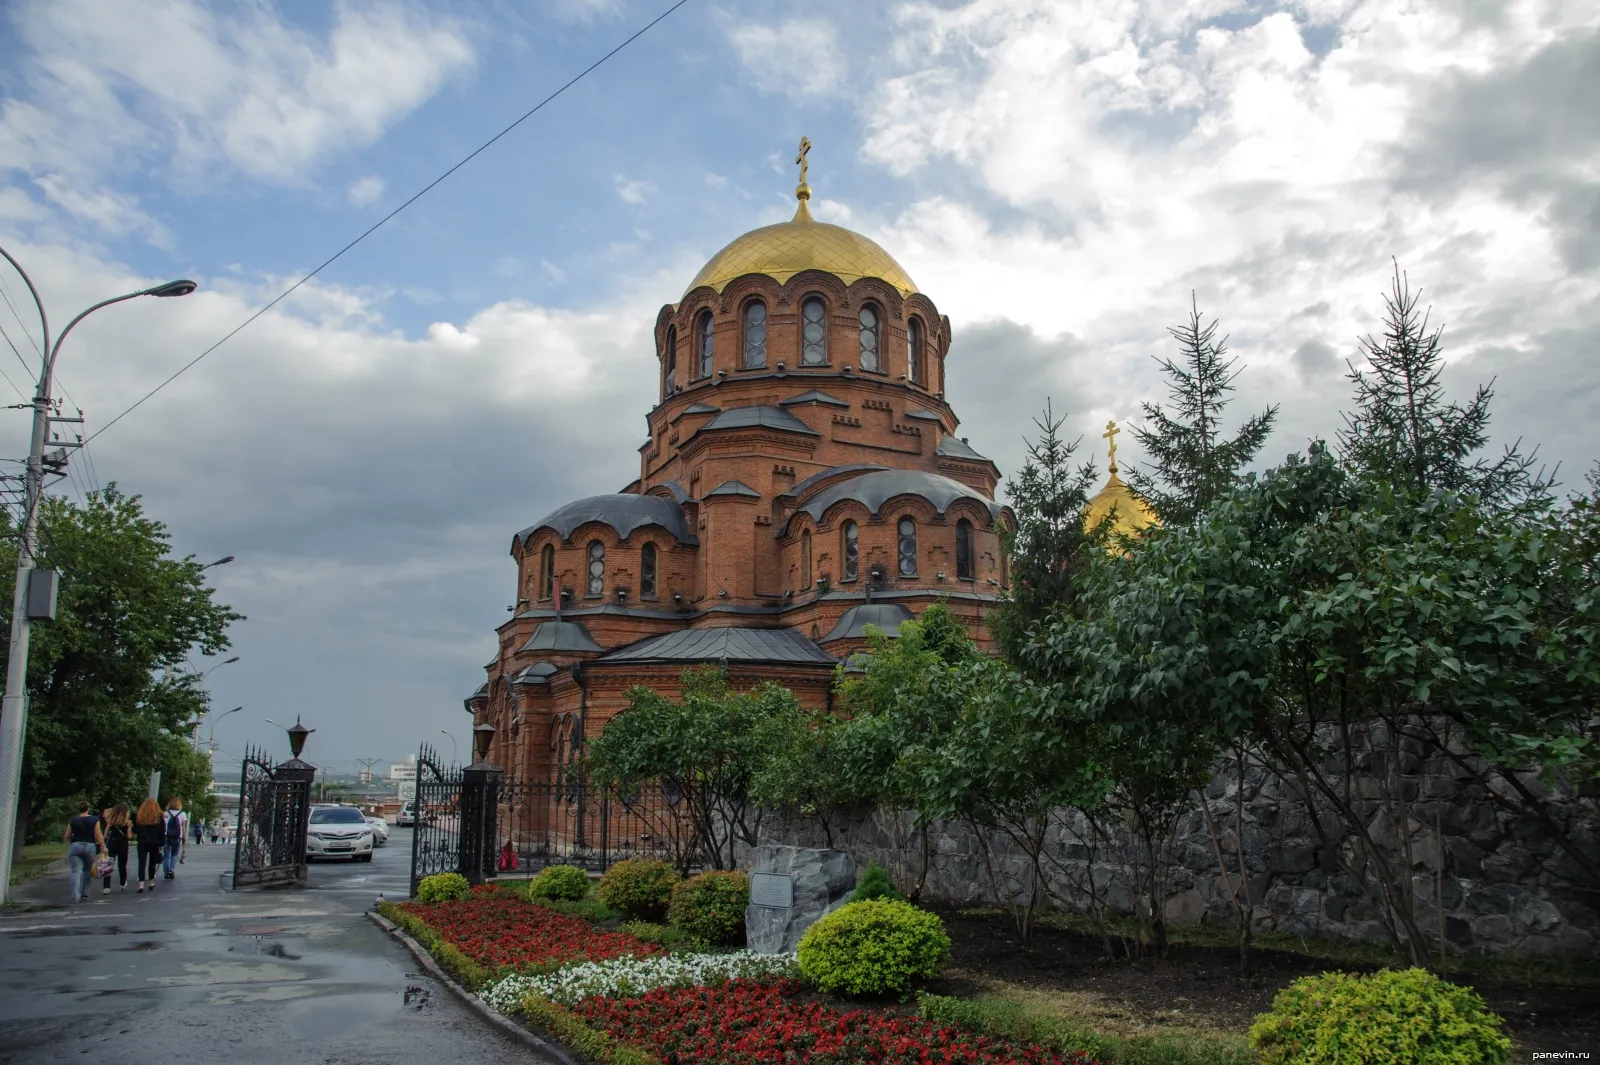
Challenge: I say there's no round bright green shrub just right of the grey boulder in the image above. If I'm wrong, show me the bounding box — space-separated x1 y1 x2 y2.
800 899 950 995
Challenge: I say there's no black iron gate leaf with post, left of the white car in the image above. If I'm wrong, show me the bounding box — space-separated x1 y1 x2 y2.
234 747 315 888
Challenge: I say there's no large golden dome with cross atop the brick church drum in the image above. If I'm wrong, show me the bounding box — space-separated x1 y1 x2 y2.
685 139 917 296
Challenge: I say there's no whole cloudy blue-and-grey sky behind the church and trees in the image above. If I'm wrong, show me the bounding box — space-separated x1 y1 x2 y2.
0 0 1600 769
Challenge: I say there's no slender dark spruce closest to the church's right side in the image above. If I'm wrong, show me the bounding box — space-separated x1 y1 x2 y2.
987 405 1102 662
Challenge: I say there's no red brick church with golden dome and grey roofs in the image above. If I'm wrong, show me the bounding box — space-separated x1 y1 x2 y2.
466 142 1011 780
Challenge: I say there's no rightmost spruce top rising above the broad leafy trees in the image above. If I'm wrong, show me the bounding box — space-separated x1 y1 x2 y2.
1339 262 1554 509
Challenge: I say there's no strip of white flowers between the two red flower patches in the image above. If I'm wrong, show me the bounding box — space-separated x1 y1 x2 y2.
478 950 795 1015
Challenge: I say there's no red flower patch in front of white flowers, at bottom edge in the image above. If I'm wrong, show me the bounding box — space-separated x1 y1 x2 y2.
573 980 1094 1065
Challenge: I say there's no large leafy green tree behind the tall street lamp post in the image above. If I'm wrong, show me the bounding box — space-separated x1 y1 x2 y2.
0 485 242 841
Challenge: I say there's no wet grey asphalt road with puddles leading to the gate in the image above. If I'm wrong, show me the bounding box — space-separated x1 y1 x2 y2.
0 830 546 1065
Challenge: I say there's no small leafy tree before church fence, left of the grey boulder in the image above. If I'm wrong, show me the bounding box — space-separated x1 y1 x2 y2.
589 668 803 868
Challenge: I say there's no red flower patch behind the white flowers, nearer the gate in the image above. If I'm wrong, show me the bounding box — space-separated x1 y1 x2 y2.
402 888 661 969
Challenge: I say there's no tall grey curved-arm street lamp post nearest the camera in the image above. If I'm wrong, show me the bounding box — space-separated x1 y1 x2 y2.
0 248 197 902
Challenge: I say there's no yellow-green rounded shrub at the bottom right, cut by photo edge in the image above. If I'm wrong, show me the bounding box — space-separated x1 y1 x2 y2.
1250 969 1510 1065
